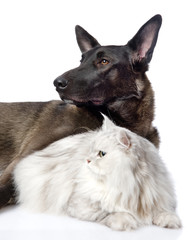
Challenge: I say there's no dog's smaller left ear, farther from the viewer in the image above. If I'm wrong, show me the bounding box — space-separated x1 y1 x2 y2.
75 25 100 53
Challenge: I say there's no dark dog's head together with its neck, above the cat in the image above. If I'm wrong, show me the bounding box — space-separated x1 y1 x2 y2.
54 15 161 147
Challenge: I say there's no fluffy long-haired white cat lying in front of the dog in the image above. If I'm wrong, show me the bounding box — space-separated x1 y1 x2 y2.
14 117 181 230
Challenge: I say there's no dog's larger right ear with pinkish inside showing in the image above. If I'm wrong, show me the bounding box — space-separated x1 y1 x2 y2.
127 15 162 69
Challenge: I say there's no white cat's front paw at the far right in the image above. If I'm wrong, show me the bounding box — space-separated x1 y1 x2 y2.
153 212 182 229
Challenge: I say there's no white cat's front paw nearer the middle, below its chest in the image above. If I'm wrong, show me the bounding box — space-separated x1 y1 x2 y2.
102 213 139 231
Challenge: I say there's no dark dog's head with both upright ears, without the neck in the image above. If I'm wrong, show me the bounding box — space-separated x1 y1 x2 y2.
54 15 162 105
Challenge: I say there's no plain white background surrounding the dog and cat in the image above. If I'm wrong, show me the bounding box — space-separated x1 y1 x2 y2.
0 0 188 240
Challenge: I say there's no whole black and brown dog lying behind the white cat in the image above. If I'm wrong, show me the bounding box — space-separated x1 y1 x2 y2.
0 15 162 206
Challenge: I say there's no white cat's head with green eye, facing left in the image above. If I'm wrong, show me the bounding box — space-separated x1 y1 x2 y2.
86 115 131 176
